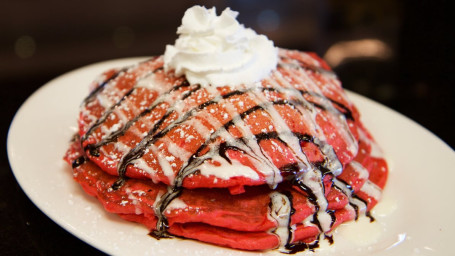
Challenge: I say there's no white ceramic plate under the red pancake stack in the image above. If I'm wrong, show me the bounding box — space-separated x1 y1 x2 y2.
8 58 455 256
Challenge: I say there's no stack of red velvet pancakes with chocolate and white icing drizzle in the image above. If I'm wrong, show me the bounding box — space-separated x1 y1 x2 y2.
65 49 387 252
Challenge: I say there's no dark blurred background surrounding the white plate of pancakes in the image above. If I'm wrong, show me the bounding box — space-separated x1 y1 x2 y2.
0 0 455 255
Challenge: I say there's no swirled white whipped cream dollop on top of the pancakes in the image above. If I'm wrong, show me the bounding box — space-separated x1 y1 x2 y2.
164 6 278 87
